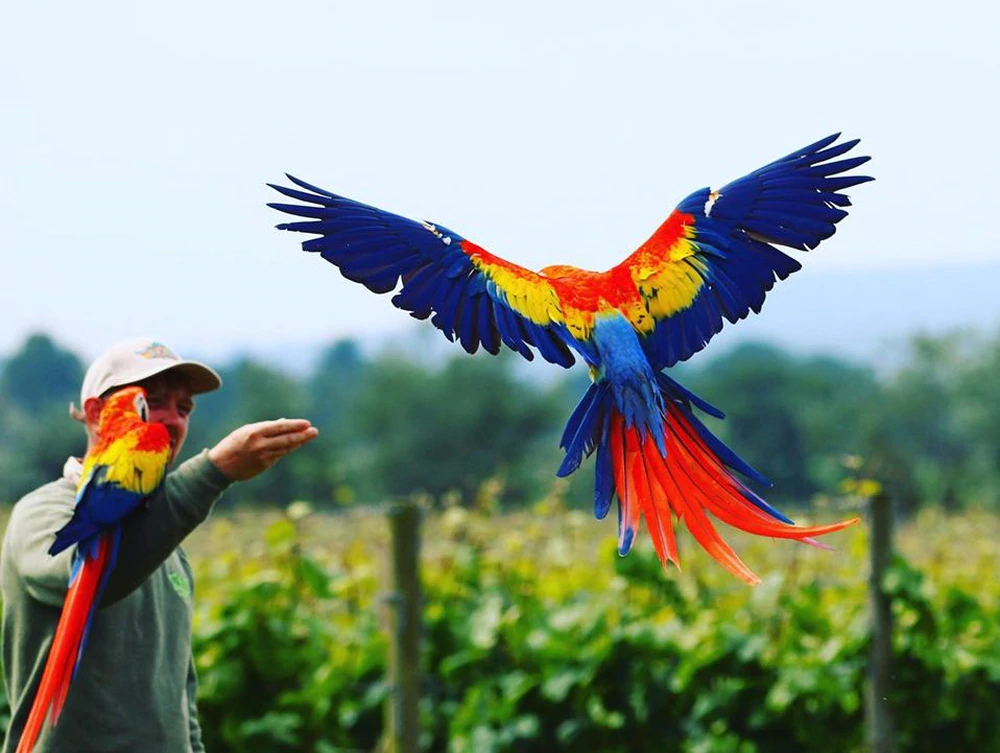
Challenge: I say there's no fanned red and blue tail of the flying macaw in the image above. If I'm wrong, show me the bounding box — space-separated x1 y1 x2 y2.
559 374 858 585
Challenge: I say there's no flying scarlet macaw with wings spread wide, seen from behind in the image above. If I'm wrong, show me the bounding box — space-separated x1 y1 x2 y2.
269 134 872 584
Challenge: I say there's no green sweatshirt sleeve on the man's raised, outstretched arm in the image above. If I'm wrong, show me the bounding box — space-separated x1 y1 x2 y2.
101 450 231 606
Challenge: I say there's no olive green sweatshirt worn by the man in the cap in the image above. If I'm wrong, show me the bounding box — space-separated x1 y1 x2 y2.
0 451 229 753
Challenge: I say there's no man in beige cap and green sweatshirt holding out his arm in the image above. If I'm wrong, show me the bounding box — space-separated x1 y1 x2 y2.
0 339 317 753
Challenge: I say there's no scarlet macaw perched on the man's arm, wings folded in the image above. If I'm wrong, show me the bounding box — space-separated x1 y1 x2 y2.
17 387 170 753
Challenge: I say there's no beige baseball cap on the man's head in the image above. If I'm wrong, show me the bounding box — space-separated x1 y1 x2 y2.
80 337 222 405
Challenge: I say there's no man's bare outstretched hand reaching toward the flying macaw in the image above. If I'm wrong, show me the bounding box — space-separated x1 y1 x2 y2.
208 418 319 481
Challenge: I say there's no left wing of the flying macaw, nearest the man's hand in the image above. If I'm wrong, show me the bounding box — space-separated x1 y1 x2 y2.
268 181 575 367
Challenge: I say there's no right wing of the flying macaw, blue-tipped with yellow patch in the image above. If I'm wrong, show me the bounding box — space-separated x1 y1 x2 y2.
620 134 871 369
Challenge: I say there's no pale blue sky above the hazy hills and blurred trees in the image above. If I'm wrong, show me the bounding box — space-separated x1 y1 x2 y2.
0 0 1000 364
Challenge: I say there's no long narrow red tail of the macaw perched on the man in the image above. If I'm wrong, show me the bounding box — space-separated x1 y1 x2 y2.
17 532 115 753
